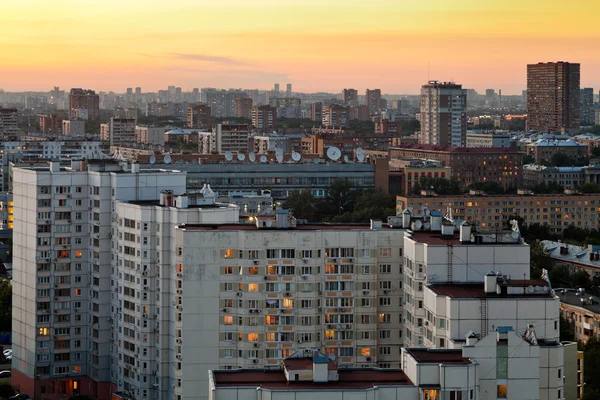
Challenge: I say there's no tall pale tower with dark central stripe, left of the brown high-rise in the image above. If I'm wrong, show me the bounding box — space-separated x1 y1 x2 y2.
419 81 467 147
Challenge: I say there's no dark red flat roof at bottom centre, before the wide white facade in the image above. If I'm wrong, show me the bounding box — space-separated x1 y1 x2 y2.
213 368 413 391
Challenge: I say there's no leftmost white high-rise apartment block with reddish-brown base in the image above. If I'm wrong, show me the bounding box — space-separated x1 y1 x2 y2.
12 161 185 399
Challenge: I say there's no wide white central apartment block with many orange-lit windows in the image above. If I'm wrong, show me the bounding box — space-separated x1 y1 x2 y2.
175 217 404 399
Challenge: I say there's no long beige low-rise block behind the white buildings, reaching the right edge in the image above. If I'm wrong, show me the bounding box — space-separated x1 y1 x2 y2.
396 194 600 233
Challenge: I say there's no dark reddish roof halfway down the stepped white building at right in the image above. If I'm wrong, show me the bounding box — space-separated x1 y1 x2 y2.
429 279 553 299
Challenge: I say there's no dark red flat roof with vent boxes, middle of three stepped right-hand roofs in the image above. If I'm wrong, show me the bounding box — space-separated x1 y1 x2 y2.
429 279 554 299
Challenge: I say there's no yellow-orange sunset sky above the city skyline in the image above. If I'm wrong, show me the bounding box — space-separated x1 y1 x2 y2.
0 0 600 94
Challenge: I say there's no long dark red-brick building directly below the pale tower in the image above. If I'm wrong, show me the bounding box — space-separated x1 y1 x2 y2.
389 144 524 189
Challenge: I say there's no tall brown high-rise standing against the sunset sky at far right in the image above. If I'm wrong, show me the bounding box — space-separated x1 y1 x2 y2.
527 61 581 133
